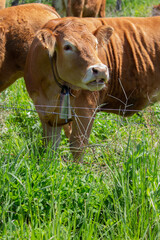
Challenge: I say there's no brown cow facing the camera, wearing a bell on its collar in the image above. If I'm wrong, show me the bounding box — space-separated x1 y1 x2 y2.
25 17 160 158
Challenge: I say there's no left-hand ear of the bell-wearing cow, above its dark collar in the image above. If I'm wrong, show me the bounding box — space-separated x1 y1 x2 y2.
36 29 56 57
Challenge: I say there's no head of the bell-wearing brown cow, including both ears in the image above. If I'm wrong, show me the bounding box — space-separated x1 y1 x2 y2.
37 18 113 91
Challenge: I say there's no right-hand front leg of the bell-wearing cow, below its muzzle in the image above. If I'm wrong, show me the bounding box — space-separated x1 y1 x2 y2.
70 91 102 161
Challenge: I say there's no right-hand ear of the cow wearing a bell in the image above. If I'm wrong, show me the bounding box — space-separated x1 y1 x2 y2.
93 26 114 45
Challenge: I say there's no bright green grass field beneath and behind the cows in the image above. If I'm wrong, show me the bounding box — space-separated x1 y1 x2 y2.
0 0 160 240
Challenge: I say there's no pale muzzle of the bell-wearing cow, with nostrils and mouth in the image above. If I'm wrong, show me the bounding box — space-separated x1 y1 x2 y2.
82 63 109 91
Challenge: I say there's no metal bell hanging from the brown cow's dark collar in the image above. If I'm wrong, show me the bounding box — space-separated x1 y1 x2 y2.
60 86 72 122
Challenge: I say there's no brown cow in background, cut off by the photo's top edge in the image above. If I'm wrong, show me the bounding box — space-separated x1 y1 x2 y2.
52 0 106 17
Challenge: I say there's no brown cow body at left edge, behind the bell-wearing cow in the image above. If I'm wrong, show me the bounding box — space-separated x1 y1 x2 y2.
0 3 59 92
